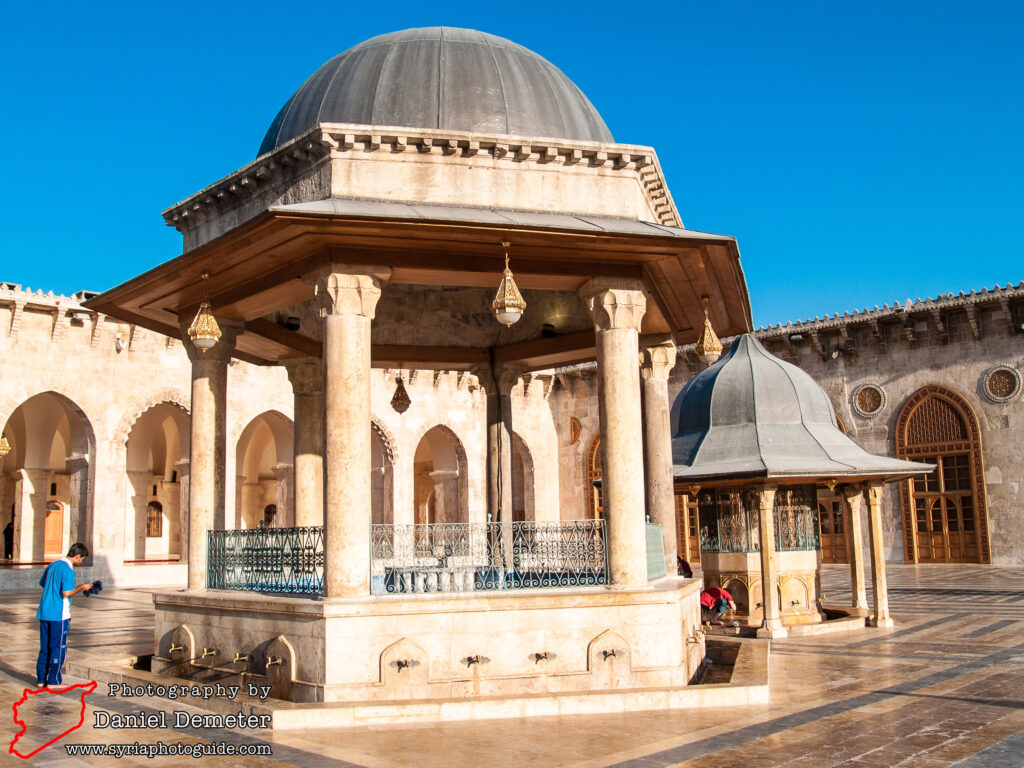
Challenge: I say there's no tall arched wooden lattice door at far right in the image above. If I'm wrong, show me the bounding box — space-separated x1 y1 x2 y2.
896 385 991 563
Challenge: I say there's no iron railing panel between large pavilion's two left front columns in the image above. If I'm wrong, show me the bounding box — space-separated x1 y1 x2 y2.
206 526 324 594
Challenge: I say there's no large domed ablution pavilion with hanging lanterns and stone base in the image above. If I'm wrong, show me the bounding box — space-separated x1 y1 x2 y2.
89 28 751 727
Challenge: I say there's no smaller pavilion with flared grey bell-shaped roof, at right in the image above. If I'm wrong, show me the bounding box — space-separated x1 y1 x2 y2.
672 334 934 637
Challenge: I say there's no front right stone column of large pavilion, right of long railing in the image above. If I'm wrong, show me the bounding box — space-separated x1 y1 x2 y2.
580 279 647 586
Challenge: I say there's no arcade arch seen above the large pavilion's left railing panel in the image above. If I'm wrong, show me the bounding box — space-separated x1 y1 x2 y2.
234 411 295 528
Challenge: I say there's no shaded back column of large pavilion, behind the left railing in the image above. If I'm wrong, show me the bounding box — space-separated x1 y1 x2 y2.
285 358 324 527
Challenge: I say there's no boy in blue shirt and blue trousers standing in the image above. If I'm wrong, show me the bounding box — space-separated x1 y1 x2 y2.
36 544 92 688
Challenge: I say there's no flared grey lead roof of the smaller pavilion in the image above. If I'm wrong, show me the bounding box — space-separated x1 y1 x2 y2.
672 334 932 481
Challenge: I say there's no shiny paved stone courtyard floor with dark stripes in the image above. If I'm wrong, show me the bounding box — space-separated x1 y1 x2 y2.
0 565 1024 768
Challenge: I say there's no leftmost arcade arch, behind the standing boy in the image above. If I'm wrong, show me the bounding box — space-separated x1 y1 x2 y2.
0 391 96 562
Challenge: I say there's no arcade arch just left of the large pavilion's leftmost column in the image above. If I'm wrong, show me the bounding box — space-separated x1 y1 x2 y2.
124 402 189 562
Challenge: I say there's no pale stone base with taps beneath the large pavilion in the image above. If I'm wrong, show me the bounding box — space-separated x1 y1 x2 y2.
153 577 703 717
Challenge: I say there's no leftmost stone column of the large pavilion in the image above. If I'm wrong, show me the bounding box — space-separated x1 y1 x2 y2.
181 317 242 590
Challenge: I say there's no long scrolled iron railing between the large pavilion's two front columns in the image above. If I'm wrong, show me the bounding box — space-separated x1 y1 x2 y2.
370 520 608 594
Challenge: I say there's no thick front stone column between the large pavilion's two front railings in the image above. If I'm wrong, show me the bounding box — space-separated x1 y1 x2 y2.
316 265 390 597
